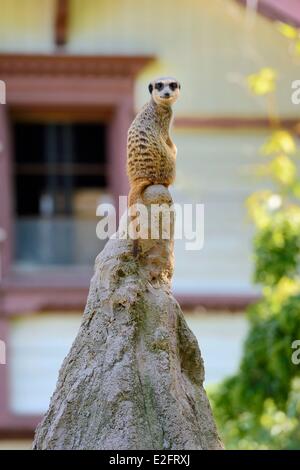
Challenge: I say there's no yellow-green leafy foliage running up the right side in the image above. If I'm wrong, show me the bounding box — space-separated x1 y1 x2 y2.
209 38 300 449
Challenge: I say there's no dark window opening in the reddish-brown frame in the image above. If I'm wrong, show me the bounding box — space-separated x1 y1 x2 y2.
13 122 108 268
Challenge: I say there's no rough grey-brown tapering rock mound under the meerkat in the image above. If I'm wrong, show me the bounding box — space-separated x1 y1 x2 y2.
33 186 222 449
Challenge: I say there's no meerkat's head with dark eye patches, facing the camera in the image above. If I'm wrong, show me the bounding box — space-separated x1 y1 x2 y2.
148 77 180 106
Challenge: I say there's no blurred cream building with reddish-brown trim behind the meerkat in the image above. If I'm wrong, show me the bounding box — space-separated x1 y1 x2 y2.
0 0 300 435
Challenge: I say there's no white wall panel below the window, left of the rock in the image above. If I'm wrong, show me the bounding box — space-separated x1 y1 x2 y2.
8 313 81 414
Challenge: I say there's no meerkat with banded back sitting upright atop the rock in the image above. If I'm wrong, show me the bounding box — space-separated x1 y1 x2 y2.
127 77 180 255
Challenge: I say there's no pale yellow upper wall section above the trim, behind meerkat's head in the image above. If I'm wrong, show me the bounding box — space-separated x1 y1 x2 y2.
67 0 299 116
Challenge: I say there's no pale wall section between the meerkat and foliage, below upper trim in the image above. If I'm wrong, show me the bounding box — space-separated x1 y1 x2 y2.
172 131 267 294
